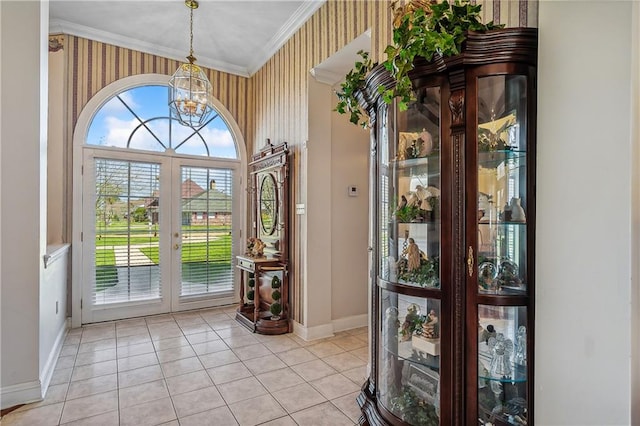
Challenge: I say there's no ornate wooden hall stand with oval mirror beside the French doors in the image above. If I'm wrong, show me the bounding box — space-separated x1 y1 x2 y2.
236 140 291 334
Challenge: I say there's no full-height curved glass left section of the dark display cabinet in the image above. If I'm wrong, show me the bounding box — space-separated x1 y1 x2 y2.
377 87 441 425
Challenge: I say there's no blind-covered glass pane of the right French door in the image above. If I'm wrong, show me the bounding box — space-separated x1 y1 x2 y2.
180 167 233 296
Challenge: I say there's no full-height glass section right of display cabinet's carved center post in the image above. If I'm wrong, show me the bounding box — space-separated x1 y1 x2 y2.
470 75 533 425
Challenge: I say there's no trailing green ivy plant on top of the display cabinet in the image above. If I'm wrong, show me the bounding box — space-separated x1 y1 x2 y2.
335 0 503 125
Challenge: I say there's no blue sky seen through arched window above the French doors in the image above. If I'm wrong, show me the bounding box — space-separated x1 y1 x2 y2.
86 86 237 158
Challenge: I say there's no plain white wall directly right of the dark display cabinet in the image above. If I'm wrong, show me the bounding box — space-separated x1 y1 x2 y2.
535 1 638 425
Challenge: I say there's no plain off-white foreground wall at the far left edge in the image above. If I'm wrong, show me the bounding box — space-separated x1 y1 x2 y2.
0 1 48 408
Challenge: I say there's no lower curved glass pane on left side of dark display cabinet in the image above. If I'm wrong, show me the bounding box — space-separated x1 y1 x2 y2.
378 290 440 425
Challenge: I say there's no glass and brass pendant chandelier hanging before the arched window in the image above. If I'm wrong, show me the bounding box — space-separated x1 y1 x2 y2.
169 0 213 128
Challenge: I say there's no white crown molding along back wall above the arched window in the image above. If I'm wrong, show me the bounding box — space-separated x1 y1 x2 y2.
49 19 252 77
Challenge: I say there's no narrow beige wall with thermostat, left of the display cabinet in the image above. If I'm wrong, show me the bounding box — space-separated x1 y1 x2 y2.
326 108 369 328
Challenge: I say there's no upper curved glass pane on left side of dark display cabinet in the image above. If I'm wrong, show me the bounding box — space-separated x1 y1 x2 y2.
378 87 441 288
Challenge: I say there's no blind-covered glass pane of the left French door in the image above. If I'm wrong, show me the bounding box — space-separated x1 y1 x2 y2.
93 158 161 305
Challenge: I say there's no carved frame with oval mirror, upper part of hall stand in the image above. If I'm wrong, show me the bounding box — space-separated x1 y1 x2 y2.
249 140 289 262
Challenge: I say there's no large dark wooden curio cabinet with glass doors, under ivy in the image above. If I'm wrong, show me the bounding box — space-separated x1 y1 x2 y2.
358 28 538 425
